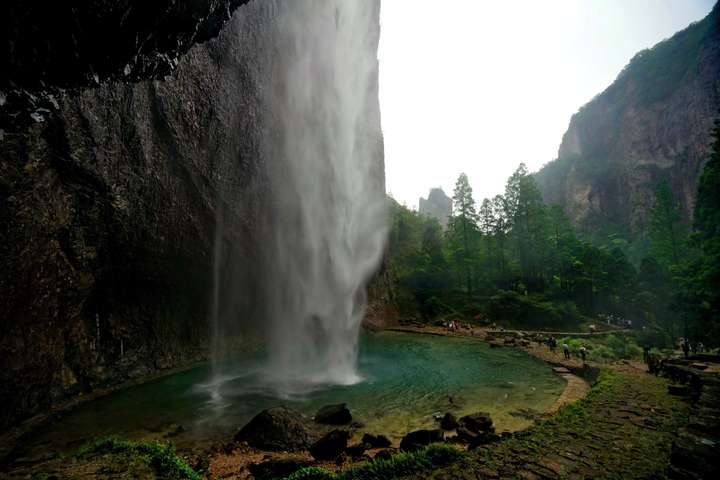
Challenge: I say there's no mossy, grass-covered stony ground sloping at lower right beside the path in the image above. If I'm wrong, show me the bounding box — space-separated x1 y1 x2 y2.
464 369 687 479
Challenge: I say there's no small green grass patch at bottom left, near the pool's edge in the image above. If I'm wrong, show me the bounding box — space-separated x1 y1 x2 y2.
75 437 203 480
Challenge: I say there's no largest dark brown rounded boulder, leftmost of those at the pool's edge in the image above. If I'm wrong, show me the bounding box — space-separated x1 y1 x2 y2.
235 407 313 452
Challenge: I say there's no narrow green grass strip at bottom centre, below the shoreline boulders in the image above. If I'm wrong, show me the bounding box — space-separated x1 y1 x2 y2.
288 444 466 480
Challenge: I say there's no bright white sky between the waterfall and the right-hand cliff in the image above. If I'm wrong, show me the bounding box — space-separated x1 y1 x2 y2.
378 0 714 208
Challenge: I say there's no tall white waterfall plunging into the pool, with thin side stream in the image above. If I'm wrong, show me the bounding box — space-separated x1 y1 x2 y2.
212 0 386 394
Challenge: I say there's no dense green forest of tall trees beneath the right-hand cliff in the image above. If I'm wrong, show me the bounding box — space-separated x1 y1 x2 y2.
389 119 720 346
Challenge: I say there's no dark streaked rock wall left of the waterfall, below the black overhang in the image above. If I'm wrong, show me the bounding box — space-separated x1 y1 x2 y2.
0 0 384 426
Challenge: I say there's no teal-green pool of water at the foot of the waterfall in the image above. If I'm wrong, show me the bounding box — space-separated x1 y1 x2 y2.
19 332 565 454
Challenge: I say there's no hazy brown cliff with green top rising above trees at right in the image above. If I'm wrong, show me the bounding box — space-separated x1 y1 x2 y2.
536 5 720 235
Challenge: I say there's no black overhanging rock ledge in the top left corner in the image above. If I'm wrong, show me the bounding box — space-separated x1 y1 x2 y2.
0 0 248 91
